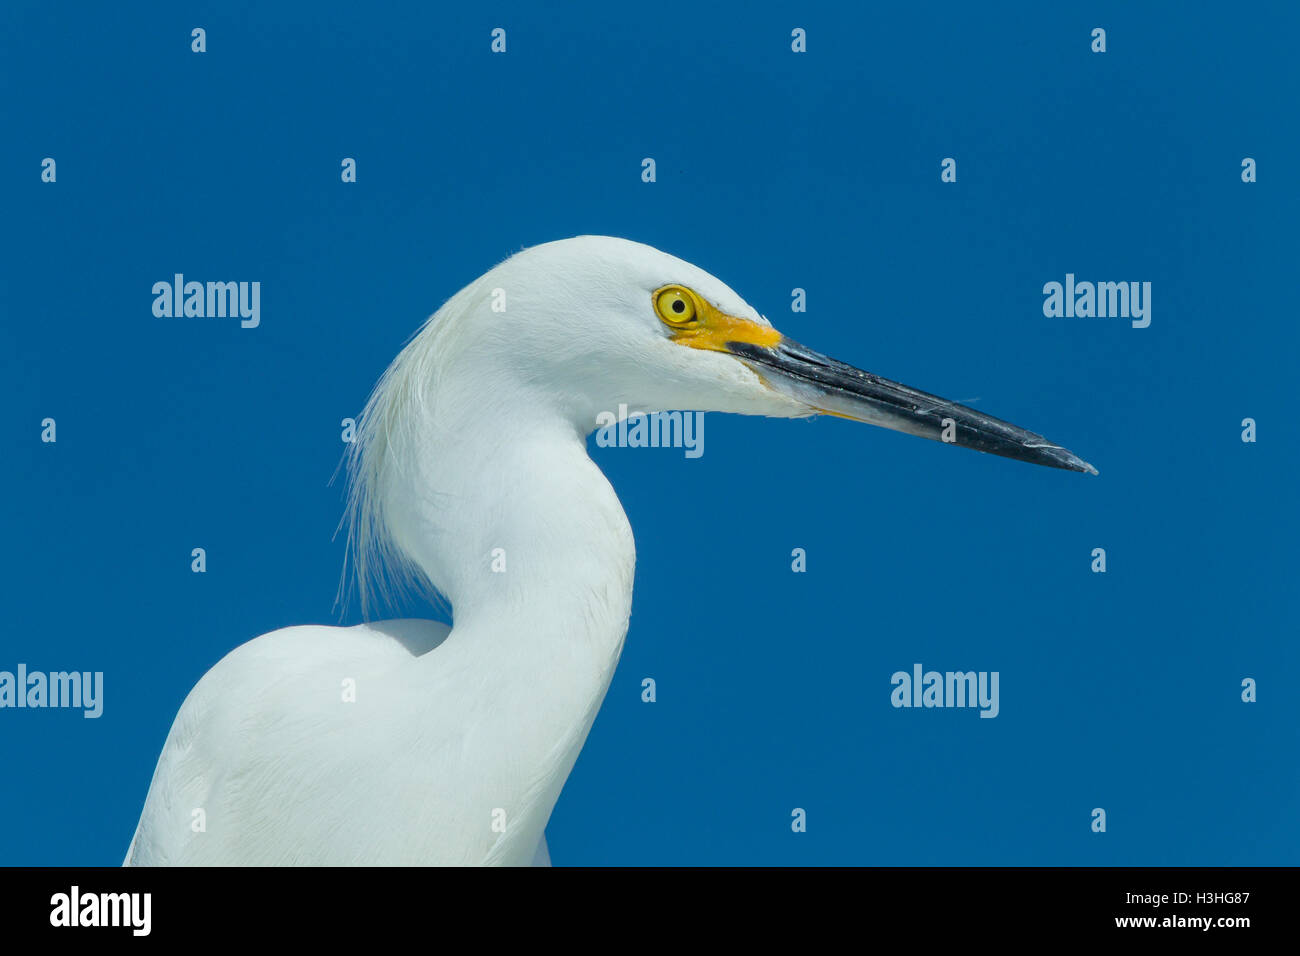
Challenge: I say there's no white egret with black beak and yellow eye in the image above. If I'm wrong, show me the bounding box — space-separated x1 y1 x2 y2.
126 237 1096 865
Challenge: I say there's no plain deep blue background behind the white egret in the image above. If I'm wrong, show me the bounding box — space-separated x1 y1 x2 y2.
0 3 1300 865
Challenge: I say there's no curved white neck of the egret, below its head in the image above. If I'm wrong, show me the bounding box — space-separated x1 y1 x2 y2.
371 380 636 860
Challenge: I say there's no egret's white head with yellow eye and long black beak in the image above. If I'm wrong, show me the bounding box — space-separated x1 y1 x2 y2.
452 235 1096 473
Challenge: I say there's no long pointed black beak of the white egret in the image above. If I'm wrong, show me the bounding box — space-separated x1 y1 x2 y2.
719 329 1097 475
